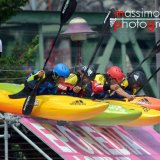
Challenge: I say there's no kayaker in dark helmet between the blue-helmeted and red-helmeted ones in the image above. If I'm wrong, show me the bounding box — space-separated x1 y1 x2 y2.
58 65 96 97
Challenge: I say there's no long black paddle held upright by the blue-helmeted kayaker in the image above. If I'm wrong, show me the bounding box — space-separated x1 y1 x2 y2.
22 0 77 115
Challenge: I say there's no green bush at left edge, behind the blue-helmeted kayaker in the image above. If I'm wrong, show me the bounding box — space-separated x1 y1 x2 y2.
0 36 38 83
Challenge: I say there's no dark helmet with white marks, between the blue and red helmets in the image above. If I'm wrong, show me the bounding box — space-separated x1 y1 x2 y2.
81 66 96 78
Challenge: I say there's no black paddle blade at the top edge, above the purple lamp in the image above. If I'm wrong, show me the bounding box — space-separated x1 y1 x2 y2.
61 0 77 25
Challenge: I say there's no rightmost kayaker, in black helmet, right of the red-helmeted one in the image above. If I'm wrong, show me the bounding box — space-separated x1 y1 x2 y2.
121 71 146 94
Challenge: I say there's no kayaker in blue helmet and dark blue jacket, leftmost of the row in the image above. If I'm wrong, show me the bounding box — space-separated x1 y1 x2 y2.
9 63 70 98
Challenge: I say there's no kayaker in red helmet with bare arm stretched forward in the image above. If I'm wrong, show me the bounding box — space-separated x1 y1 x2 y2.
91 66 135 101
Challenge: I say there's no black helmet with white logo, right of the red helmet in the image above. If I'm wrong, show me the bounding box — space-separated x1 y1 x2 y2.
128 71 146 87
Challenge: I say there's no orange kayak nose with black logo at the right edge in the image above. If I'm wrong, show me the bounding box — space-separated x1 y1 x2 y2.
128 96 160 111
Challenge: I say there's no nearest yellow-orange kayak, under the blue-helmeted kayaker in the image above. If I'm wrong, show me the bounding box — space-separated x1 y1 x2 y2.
0 83 108 121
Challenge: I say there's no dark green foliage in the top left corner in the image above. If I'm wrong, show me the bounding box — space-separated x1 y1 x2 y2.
0 0 28 23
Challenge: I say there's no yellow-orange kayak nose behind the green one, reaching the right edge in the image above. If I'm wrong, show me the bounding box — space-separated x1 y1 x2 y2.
104 99 160 126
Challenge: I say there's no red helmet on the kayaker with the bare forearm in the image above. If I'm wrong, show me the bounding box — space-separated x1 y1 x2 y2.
106 66 125 83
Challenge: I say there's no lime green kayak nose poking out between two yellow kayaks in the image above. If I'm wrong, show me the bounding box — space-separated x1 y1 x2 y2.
84 103 142 126
